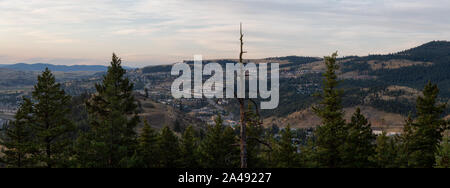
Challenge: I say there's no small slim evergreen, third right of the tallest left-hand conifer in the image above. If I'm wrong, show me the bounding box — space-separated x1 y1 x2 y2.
181 126 199 168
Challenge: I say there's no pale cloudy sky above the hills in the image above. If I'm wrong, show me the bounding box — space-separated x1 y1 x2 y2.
0 0 450 67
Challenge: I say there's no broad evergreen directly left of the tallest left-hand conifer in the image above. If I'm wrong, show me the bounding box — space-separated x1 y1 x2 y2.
31 68 75 168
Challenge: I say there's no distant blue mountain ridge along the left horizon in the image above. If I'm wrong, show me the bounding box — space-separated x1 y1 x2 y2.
0 63 132 72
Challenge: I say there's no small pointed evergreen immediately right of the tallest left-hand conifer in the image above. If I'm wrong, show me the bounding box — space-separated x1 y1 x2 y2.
138 120 159 168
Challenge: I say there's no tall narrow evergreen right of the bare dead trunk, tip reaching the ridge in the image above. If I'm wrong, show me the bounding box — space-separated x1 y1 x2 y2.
313 53 347 168
